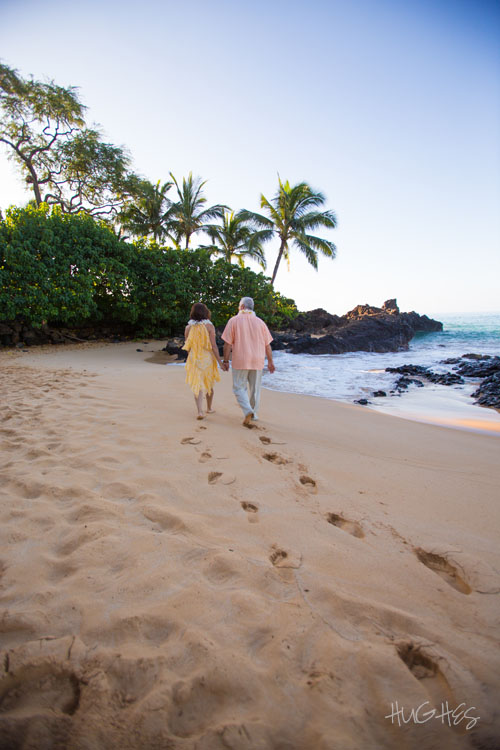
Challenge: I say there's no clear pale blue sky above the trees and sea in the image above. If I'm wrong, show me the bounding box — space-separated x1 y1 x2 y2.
0 0 500 313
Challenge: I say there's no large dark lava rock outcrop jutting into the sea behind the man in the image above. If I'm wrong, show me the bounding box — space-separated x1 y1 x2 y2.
272 299 443 354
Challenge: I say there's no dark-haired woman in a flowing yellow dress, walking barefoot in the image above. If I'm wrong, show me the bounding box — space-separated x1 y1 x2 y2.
182 302 224 419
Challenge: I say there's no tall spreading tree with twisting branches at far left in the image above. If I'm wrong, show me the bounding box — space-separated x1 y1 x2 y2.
0 64 138 217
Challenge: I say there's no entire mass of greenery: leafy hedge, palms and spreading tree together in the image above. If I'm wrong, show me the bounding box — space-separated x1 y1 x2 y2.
0 63 337 333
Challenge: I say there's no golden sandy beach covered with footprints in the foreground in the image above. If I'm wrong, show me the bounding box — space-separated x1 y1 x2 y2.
0 342 500 750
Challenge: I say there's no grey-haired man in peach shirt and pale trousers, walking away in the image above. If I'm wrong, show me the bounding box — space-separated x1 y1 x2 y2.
222 297 275 427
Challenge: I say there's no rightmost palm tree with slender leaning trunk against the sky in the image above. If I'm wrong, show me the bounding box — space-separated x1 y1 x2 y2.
240 179 337 284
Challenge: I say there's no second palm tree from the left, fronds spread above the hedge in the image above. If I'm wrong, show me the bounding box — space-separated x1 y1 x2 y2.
170 172 227 250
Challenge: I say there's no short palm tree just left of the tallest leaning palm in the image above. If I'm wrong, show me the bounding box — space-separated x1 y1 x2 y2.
205 211 272 269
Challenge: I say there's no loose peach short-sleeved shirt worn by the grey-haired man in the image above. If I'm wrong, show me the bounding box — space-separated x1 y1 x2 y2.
222 310 273 370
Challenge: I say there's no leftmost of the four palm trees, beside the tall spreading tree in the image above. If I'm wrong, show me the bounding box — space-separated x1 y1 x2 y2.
120 180 173 242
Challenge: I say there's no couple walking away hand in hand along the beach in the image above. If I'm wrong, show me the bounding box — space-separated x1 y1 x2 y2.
183 297 275 427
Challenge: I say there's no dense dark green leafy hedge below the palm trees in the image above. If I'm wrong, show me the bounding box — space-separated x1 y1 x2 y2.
0 204 297 336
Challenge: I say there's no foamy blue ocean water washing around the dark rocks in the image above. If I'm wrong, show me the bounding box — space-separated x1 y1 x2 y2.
263 313 500 435
